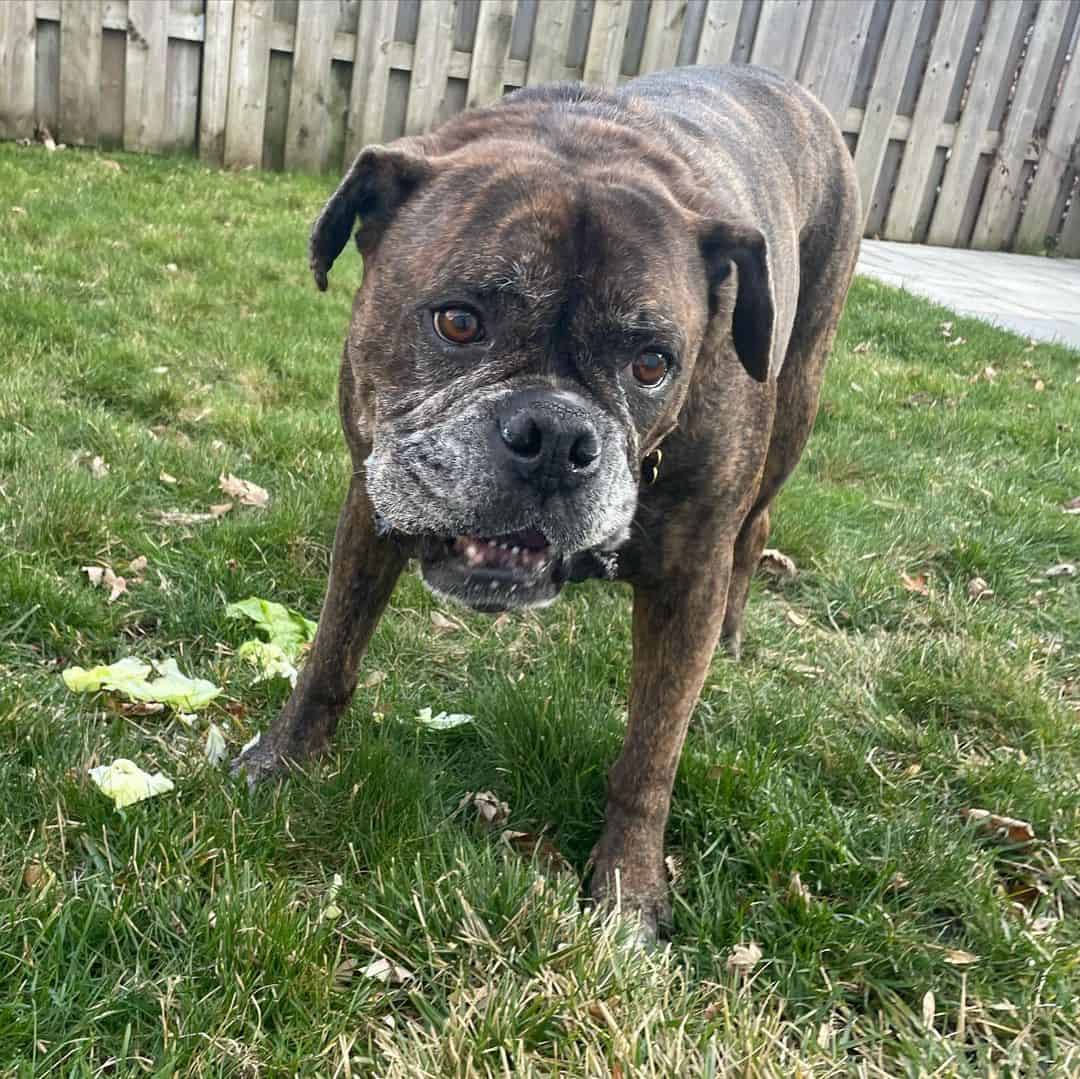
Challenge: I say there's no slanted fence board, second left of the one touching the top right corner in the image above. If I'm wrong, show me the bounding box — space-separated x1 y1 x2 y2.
885 0 978 242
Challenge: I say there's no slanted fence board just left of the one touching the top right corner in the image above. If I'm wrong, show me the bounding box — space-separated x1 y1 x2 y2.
927 3 1031 247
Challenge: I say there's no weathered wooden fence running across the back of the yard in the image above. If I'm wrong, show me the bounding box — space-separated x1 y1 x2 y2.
0 0 1080 256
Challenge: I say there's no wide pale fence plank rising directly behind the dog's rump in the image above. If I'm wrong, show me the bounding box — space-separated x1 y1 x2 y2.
798 0 874 122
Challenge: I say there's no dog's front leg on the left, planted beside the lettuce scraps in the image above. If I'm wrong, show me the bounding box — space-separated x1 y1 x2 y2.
233 474 405 784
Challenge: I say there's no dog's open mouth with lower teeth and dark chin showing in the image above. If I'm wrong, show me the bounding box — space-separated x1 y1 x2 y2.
420 528 565 611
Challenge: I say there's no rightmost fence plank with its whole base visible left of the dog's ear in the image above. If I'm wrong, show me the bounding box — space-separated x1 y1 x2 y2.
285 3 338 173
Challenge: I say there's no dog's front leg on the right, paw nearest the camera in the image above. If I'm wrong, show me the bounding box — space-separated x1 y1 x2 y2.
592 540 732 936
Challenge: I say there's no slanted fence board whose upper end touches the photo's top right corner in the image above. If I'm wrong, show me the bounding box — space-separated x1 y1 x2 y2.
971 3 1076 248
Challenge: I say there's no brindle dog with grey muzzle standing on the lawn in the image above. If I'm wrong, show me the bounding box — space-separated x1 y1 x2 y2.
237 66 862 934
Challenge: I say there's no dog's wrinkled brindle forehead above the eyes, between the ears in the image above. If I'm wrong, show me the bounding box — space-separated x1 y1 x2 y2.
406 167 700 319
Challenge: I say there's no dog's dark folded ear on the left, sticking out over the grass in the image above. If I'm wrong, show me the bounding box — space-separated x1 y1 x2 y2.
308 146 431 292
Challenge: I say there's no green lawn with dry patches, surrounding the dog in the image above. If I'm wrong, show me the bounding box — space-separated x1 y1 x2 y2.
0 146 1080 1076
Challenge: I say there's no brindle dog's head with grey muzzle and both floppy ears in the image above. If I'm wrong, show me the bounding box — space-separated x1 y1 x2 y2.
311 117 772 611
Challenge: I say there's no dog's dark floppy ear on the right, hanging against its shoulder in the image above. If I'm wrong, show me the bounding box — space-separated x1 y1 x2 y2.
701 221 783 382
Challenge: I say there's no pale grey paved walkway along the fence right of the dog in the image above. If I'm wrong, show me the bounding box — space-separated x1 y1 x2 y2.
859 240 1080 349
